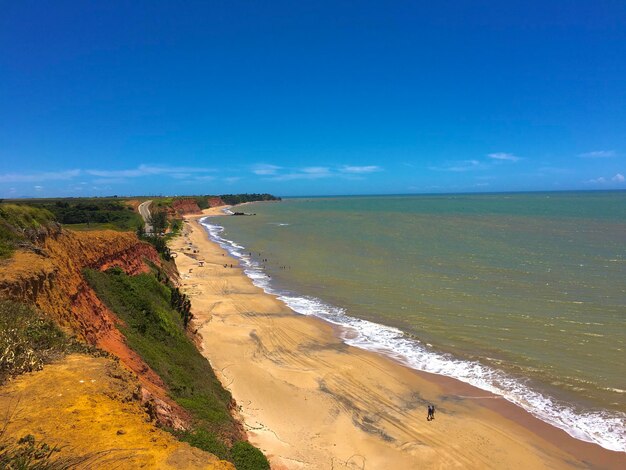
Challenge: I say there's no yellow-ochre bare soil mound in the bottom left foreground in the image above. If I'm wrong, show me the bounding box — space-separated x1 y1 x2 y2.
0 354 234 470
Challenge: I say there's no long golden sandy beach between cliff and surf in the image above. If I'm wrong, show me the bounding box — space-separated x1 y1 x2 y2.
170 208 626 469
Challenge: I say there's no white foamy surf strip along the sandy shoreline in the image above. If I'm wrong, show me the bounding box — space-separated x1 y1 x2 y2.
200 217 626 452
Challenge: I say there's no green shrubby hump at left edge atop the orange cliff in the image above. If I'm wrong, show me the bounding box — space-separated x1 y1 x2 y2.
0 204 54 259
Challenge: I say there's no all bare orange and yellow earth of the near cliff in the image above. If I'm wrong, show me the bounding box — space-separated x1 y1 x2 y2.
0 224 235 469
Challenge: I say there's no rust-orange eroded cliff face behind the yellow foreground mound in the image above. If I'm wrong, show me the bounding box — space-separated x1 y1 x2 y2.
0 230 188 429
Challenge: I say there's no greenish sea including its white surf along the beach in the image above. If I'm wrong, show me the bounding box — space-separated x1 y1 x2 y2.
205 192 626 451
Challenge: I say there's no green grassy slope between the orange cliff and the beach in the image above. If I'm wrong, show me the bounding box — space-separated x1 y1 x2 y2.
85 268 269 470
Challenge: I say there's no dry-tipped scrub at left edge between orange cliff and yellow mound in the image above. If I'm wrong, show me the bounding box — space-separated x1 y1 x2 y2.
0 300 95 384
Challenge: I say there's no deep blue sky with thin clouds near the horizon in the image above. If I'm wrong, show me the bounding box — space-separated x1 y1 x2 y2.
0 0 626 198
